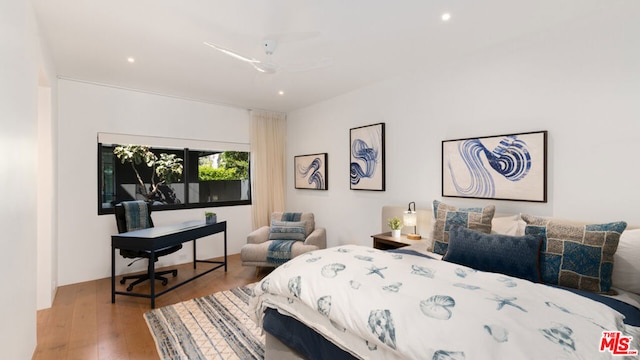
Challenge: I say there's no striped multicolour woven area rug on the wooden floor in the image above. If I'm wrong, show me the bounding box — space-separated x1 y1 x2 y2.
144 284 264 360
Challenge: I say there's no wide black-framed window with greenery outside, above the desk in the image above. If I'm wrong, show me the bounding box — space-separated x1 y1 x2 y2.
98 136 251 214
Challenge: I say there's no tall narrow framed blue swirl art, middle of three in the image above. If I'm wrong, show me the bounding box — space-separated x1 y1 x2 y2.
349 123 385 191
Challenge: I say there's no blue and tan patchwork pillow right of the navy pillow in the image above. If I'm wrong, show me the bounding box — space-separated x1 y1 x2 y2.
522 214 627 293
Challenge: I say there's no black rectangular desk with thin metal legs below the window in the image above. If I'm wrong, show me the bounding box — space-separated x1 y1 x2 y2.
111 220 227 308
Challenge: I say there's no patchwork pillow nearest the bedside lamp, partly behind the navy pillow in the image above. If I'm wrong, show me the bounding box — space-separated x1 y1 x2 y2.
429 200 496 255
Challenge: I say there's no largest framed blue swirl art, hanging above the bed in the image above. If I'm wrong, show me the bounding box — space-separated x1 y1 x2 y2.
442 131 547 202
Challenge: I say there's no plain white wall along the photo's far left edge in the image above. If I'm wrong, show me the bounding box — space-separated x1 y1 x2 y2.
0 0 52 359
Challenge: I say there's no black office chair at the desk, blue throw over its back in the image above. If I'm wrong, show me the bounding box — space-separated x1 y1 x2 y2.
115 201 182 291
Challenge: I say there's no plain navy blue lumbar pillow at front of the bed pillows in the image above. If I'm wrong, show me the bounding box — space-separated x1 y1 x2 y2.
442 226 542 282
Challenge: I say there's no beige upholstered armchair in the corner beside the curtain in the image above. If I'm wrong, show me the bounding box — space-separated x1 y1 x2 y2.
240 212 327 273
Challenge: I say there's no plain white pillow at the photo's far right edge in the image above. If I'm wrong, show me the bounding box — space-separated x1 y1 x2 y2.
611 229 640 294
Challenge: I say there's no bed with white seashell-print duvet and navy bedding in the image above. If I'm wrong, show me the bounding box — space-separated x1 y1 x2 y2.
251 204 640 359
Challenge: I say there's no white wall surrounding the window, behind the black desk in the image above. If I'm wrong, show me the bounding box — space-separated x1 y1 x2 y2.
57 80 251 285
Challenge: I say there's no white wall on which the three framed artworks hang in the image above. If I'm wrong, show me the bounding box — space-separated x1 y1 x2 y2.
286 2 640 246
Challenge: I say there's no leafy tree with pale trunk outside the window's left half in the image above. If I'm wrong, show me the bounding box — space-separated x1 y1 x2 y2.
113 145 182 203
